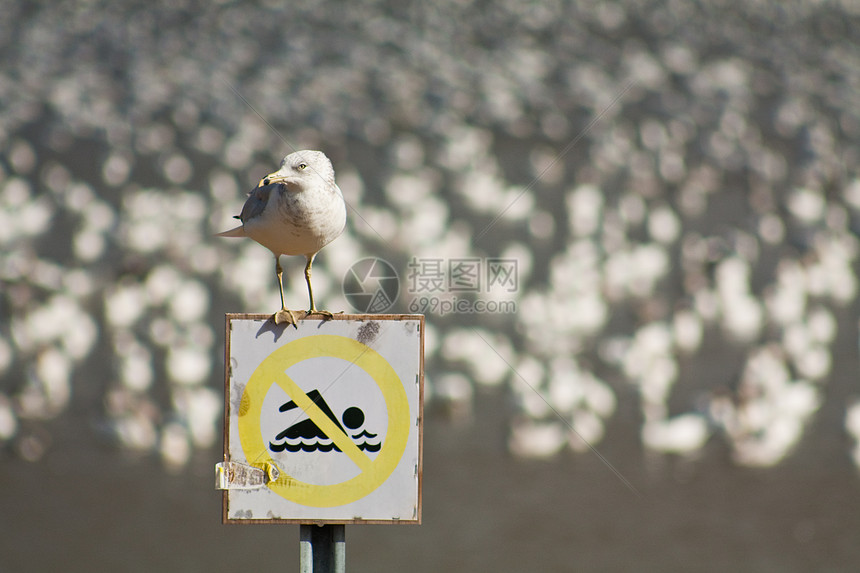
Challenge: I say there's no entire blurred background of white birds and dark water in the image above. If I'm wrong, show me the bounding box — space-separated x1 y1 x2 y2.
0 0 860 573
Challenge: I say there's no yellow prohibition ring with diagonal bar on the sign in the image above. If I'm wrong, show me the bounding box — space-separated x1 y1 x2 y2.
239 334 411 507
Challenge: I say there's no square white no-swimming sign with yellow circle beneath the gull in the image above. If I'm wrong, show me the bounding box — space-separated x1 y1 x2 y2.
218 314 424 523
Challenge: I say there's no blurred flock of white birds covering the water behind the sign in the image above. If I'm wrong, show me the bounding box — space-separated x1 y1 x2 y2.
0 0 860 468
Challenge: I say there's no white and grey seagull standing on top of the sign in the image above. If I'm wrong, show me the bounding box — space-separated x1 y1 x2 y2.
218 150 346 328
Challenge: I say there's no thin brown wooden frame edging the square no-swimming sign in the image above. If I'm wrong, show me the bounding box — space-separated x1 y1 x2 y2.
221 312 425 525
